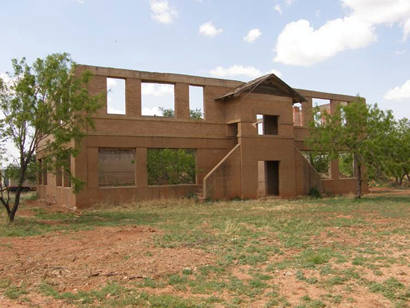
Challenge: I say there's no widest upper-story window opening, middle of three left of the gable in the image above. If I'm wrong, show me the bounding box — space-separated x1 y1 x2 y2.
141 82 175 117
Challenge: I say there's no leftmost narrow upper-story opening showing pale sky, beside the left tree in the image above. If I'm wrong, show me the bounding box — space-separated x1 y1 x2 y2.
107 78 126 115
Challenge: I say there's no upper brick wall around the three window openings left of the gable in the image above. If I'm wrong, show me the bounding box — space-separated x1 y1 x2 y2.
79 65 243 122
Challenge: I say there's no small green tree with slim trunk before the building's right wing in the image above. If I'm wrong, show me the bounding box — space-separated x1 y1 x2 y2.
307 97 394 198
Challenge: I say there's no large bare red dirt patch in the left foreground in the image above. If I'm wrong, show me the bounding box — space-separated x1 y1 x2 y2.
0 227 214 292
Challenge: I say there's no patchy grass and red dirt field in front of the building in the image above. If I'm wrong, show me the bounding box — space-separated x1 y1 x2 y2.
0 191 410 308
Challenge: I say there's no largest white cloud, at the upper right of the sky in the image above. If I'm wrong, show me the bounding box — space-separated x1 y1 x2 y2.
274 0 410 66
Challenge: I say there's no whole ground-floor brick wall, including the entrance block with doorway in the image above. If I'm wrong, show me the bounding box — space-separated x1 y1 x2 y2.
38 136 367 208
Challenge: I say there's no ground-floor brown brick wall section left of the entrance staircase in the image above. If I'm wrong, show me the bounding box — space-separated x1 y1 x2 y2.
61 136 235 208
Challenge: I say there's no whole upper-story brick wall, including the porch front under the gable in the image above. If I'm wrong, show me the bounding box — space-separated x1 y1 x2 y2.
79 65 364 141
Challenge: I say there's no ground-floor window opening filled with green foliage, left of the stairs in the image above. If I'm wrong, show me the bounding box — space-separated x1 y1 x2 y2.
147 149 196 185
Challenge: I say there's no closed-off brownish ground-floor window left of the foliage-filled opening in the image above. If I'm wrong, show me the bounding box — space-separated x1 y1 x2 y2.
98 148 135 186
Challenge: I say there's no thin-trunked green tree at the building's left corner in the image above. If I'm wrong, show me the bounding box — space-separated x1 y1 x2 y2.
0 53 100 222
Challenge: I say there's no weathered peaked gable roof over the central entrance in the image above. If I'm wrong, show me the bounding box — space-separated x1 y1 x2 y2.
216 74 306 103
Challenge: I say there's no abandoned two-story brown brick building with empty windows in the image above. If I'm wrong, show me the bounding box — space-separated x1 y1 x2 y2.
38 66 366 207
